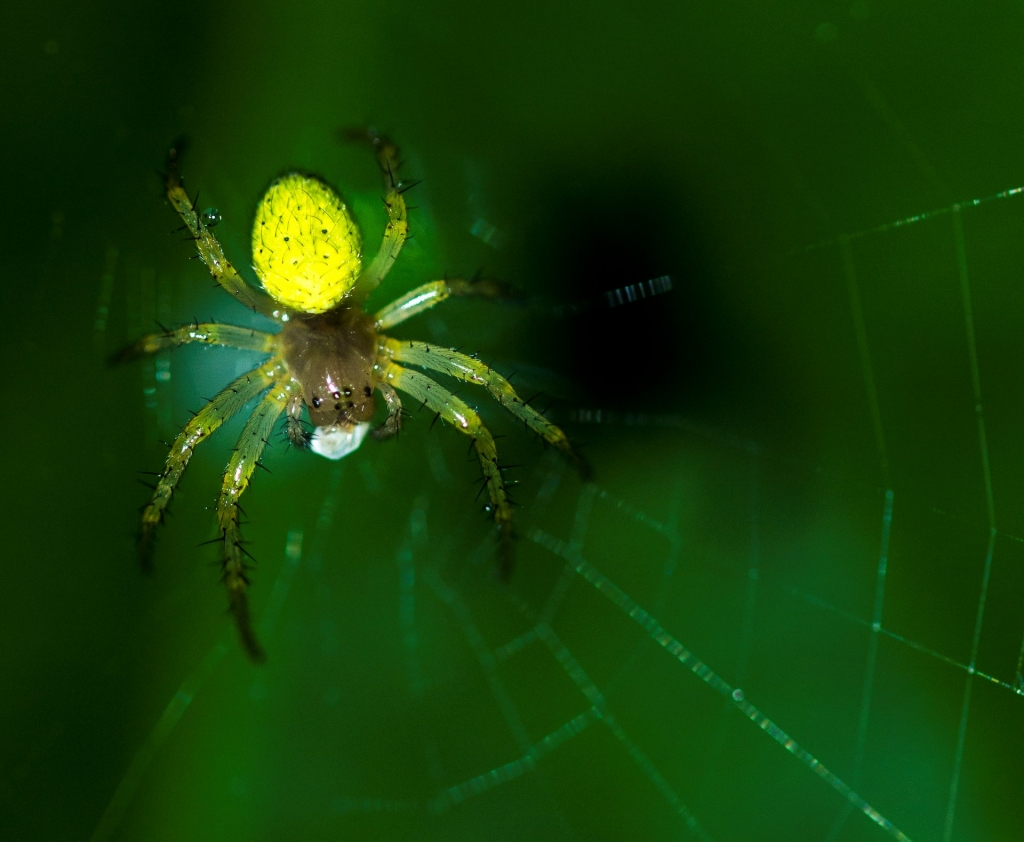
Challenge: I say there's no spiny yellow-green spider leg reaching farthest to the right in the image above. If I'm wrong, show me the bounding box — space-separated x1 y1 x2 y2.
383 337 590 477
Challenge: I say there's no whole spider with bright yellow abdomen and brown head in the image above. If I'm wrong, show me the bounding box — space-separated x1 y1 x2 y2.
115 130 585 663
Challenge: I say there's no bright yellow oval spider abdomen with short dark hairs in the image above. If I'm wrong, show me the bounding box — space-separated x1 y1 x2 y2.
253 172 362 312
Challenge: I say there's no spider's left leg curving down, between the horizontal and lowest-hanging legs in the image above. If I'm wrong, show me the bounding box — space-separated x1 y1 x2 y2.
138 360 285 567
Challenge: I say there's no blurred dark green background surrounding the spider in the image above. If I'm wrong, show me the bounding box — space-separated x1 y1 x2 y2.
0 0 1024 842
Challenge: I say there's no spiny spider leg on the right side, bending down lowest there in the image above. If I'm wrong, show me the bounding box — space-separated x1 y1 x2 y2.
384 363 512 578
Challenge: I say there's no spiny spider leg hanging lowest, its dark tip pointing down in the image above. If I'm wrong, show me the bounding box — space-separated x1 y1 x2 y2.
217 379 299 663
